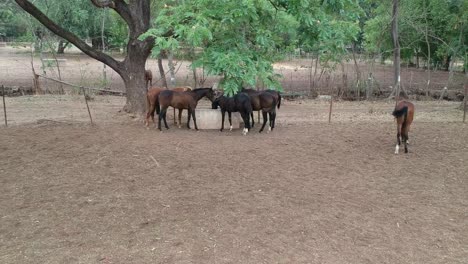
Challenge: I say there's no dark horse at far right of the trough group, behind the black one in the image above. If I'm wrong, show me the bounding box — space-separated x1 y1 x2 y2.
244 89 278 133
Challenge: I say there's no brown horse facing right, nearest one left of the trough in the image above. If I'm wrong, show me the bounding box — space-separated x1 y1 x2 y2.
158 88 214 130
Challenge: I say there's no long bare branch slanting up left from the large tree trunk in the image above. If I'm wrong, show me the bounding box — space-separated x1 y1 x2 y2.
15 0 122 73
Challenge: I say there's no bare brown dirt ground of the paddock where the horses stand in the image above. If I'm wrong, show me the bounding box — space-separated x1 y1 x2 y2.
0 96 468 263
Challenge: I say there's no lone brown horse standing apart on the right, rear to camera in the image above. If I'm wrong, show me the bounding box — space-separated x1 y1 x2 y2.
392 101 414 154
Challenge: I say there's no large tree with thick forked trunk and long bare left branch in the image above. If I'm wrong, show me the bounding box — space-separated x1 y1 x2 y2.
15 0 154 113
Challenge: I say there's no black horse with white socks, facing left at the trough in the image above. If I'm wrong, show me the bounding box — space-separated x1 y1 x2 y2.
211 93 252 136
